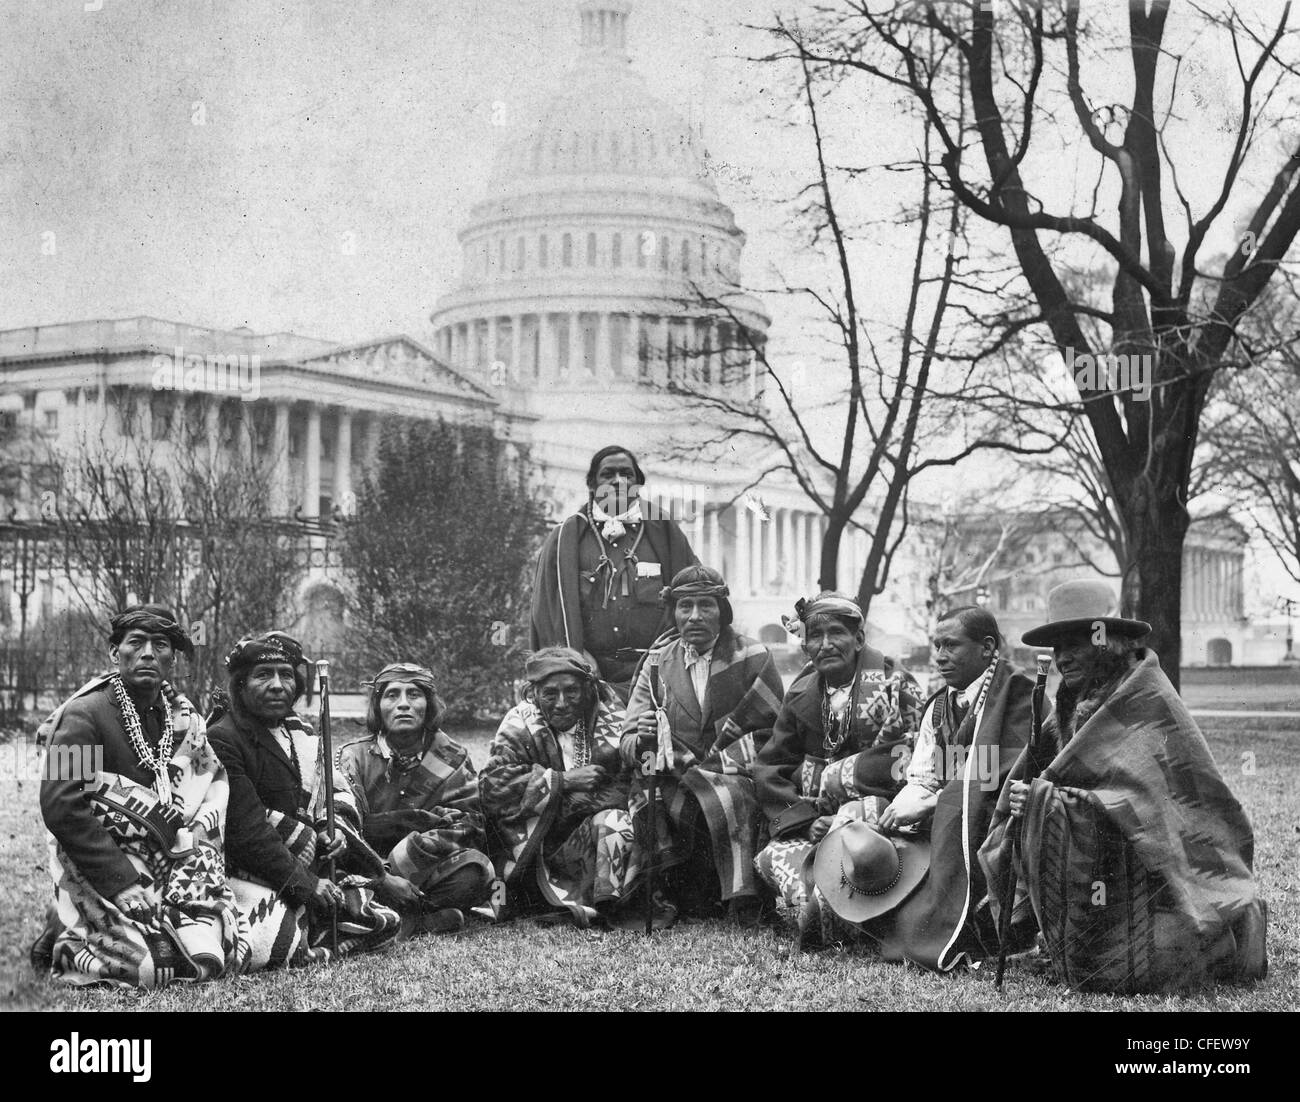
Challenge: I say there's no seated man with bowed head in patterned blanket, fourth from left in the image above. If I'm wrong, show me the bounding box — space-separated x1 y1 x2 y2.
478 647 637 927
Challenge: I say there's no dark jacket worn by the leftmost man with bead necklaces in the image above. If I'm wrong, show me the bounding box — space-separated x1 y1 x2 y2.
40 684 170 899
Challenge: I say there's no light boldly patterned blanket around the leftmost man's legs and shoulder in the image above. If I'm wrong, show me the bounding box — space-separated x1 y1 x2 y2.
48 706 250 988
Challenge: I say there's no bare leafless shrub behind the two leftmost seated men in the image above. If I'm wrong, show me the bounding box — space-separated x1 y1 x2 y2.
51 391 303 707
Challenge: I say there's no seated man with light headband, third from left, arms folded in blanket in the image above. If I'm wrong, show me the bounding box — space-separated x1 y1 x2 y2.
338 661 493 934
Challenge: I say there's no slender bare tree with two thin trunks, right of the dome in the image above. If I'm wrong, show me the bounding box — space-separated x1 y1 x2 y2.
662 19 1054 611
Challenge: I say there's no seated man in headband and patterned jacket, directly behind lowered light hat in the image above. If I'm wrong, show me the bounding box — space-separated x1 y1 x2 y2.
754 593 920 949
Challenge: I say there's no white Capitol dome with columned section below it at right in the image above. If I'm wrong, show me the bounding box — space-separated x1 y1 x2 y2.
430 0 853 642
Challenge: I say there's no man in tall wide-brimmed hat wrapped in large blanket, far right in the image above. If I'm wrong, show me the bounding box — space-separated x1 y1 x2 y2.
979 581 1266 994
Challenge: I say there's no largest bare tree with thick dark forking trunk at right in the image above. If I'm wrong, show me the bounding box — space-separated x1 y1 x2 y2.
785 0 1300 684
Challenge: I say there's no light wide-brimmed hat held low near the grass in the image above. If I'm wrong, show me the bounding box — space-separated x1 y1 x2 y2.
813 820 930 923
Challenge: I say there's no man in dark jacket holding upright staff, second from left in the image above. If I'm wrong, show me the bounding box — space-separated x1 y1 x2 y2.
208 632 400 969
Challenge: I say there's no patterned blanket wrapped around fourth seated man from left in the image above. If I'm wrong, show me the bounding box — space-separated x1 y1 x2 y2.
478 702 640 928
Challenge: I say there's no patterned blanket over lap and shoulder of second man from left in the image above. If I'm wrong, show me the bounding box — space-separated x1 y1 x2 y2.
230 716 402 971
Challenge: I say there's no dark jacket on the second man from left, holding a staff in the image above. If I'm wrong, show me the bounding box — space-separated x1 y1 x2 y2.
208 712 320 907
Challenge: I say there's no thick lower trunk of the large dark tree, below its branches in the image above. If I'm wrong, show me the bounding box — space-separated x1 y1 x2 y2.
1127 502 1190 689
